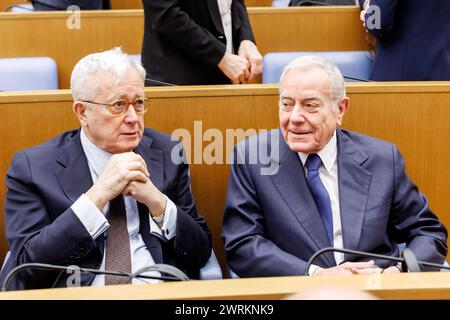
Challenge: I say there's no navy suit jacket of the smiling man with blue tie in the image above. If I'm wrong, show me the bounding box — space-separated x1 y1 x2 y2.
222 129 447 277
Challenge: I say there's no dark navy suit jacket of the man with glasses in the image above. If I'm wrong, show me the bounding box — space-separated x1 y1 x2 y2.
0 129 211 289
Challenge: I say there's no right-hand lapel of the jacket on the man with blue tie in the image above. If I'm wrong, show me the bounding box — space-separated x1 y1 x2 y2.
336 130 372 250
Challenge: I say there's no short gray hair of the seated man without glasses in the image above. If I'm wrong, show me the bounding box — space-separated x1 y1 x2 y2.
280 56 345 107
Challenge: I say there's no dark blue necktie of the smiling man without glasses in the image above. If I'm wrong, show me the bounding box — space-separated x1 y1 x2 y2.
305 153 333 246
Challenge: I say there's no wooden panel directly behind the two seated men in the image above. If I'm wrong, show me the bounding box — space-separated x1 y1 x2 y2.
0 82 450 272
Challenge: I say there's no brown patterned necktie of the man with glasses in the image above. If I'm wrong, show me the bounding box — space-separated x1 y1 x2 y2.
105 195 131 285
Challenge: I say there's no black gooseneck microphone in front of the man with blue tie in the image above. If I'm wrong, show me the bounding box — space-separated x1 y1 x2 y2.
305 247 450 276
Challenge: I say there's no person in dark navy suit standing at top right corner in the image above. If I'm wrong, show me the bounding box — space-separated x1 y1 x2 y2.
360 0 450 81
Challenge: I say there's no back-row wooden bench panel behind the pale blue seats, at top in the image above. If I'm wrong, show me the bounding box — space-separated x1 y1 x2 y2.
0 6 367 88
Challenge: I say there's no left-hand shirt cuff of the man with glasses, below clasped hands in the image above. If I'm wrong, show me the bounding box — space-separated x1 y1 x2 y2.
70 193 109 240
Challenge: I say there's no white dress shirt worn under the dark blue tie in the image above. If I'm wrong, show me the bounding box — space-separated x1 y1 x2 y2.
298 131 344 275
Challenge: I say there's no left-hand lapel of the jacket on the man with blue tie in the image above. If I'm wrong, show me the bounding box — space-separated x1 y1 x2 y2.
272 131 336 266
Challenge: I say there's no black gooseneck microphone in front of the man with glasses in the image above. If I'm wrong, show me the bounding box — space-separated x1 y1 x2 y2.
1 263 189 291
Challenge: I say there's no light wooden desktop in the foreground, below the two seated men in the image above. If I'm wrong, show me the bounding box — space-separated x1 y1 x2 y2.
0 272 450 300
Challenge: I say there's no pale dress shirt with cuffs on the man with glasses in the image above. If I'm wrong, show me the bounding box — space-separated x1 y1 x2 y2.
71 129 177 286
